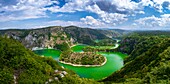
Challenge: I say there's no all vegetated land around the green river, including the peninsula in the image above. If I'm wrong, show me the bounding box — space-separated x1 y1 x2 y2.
0 26 170 84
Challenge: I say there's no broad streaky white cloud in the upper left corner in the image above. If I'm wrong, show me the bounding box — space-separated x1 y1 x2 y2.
0 0 58 22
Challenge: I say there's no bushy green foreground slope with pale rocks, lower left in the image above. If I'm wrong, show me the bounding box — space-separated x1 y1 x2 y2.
0 37 97 84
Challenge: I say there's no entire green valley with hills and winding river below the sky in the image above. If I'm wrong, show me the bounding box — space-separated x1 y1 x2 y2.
0 26 170 84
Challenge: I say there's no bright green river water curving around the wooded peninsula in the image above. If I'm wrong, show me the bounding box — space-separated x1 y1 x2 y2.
34 45 127 80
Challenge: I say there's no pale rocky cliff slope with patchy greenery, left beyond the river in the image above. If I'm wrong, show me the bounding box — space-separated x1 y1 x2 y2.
0 26 73 49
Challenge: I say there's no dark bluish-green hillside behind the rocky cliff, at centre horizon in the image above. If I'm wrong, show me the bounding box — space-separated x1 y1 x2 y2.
63 26 109 44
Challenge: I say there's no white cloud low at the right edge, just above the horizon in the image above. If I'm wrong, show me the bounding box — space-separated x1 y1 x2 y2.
135 15 170 28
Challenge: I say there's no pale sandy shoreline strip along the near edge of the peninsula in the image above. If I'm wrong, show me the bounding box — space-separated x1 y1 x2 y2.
59 56 107 67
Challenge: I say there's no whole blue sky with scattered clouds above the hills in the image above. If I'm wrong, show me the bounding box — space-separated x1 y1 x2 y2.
0 0 170 30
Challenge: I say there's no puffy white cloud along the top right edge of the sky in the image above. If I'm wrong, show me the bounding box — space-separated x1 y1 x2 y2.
111 0 170 13
